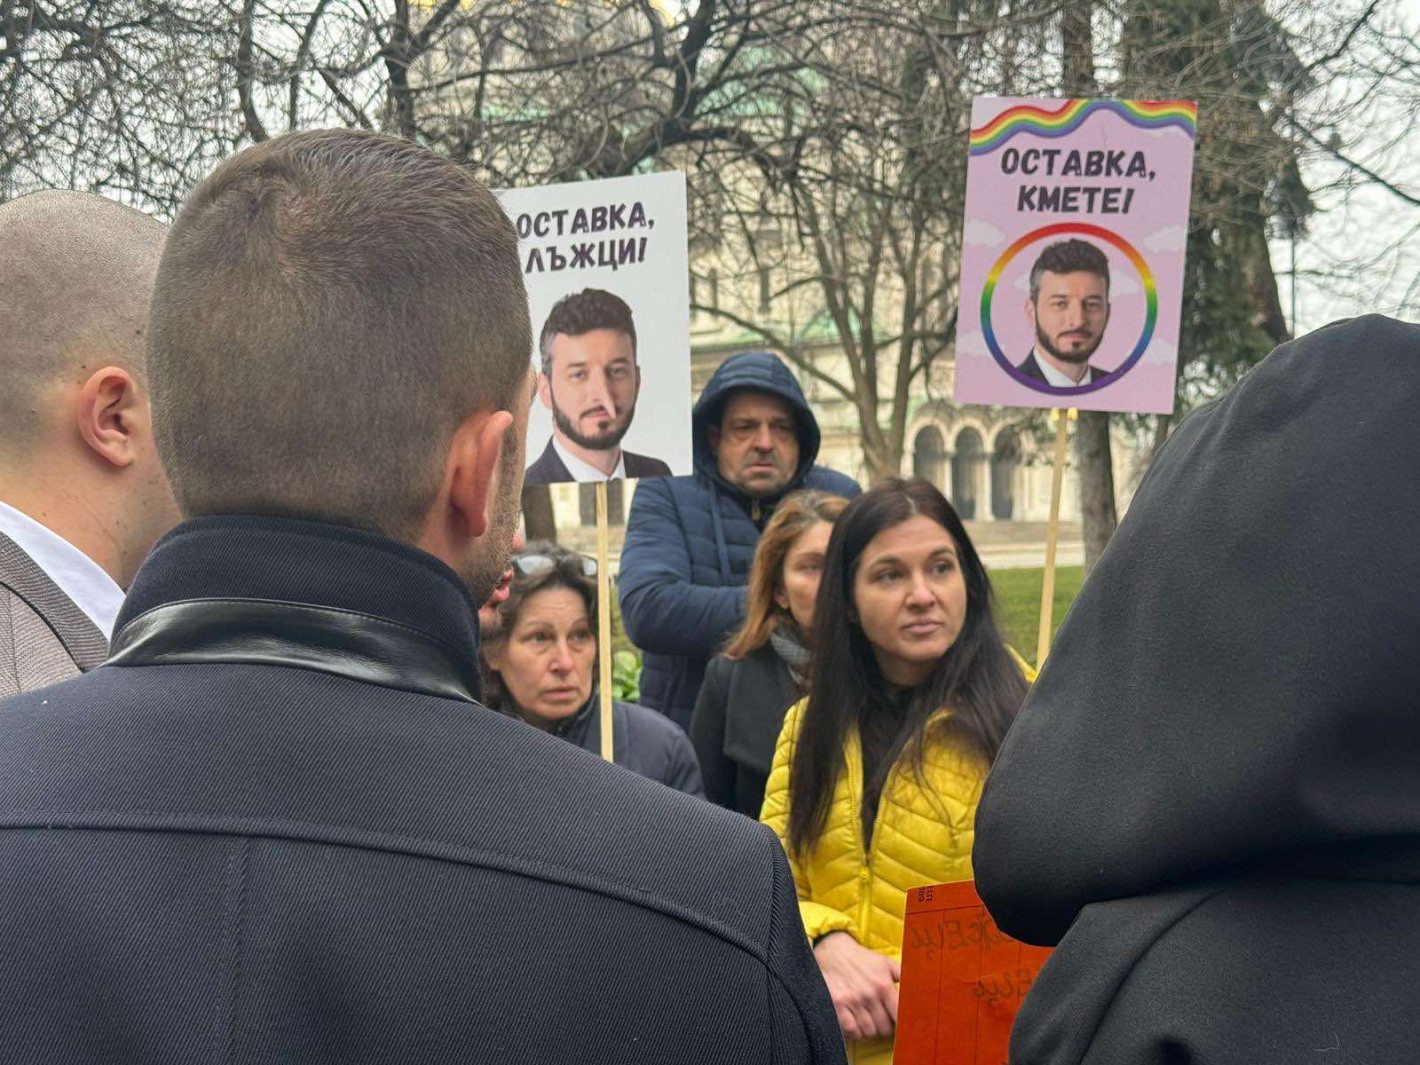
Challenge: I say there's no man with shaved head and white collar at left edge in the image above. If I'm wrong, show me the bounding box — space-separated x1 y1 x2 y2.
0 192 179 697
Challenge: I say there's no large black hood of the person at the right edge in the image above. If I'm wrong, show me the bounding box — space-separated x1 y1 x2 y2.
976 315 1420 943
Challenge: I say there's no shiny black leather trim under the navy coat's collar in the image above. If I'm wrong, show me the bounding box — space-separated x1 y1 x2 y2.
104 599 479 703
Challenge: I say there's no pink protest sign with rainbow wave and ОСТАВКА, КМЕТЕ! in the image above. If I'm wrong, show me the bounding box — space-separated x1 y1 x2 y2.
954 97 1198 415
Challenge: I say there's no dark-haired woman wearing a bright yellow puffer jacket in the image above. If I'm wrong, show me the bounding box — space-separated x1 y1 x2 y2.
760 480 1034 1065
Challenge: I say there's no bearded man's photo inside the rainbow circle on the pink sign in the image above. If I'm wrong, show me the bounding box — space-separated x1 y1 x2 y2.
1017 240 1109 389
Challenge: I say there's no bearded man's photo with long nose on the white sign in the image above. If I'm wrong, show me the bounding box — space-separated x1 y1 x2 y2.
524 288 670 486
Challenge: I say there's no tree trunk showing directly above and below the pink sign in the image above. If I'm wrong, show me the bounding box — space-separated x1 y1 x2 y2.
1061 0 1119 574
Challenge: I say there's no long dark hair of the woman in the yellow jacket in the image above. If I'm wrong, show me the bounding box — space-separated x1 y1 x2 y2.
788 477 1027 853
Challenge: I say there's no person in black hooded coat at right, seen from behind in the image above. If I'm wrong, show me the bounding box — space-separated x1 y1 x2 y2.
974 315 1420 1065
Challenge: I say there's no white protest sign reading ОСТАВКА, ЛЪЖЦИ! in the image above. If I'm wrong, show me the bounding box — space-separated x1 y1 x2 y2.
498 172 692 484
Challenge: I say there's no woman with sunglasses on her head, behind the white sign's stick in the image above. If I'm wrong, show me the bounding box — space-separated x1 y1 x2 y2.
481 544 704 795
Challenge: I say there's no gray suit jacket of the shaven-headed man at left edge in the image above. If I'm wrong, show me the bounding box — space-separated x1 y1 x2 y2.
0 535 108 699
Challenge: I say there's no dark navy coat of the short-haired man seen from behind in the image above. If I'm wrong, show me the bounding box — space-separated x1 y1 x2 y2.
0 515 843 1065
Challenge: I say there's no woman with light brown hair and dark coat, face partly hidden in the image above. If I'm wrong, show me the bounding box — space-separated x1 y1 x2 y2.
690 491 848 818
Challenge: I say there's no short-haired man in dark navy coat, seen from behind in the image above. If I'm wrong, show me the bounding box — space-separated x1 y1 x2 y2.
0 131 843 1065
